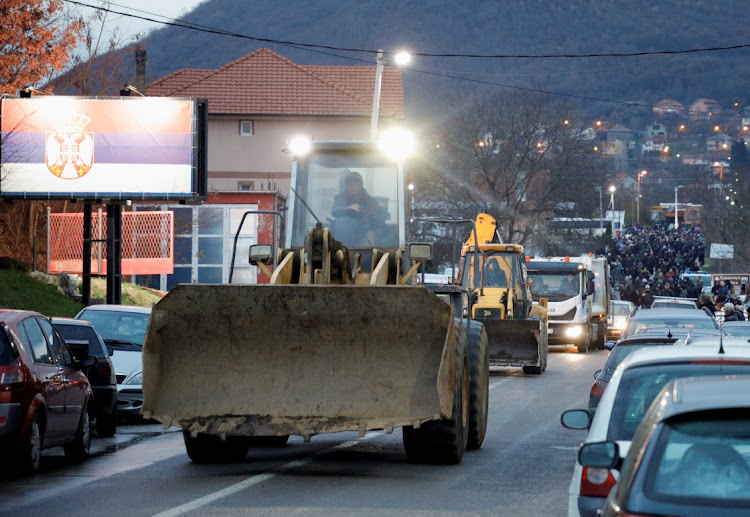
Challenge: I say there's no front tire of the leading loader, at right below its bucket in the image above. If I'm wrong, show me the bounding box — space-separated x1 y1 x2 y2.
403 324 469 465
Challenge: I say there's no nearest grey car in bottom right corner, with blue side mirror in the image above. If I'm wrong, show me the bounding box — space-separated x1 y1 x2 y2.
579 377 750 517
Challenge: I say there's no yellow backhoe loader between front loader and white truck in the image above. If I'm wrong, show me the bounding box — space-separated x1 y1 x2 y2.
459 214 548 375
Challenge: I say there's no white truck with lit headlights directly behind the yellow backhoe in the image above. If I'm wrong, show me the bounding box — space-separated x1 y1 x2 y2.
526 257 606 353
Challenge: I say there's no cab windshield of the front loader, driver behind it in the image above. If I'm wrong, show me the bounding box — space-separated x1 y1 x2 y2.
290 151 401 249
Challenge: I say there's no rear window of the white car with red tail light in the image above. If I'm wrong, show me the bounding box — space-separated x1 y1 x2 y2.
607 362 750 441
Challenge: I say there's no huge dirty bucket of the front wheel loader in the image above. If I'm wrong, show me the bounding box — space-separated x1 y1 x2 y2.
142 284 455 438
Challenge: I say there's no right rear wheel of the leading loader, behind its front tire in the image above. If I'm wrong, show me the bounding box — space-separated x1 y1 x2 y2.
466 321 490 451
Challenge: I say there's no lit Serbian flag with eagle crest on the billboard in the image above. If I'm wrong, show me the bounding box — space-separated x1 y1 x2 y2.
0 96 195 199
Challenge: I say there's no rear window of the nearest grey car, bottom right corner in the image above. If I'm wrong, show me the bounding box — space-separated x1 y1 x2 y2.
644 409 750 508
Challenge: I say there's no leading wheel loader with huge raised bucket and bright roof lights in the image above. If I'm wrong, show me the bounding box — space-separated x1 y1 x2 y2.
142 138 489 463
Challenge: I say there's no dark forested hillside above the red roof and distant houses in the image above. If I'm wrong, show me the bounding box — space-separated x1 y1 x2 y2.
140 0 750 119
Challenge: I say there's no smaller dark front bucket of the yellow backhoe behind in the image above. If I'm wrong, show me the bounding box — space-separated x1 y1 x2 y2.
481 319 546 366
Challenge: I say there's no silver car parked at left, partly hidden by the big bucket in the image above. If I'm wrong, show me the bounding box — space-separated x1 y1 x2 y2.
76 305 151 418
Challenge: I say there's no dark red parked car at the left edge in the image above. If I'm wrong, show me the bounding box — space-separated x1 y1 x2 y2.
0 310 96 473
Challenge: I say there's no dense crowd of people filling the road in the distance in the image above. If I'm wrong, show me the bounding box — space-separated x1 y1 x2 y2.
607 225 747 321
